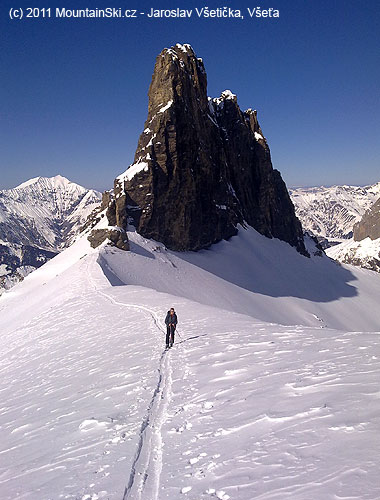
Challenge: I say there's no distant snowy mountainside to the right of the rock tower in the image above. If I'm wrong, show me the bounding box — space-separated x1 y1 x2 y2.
289 182 380 241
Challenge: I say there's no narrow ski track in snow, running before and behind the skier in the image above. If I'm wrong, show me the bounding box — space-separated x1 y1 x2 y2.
88 256 173 500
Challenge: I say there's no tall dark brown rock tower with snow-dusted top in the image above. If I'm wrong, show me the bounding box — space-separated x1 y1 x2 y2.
112 44 308 255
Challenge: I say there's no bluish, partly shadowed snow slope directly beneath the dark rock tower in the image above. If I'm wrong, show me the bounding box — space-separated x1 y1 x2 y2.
100 229 380 330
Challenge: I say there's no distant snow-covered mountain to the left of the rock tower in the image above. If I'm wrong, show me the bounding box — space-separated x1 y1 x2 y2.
0 175 101 292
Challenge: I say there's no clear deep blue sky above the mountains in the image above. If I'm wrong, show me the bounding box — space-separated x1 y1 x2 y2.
0 0 380 190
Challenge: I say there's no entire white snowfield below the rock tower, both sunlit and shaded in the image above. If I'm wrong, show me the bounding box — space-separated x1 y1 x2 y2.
0 230 380 500
